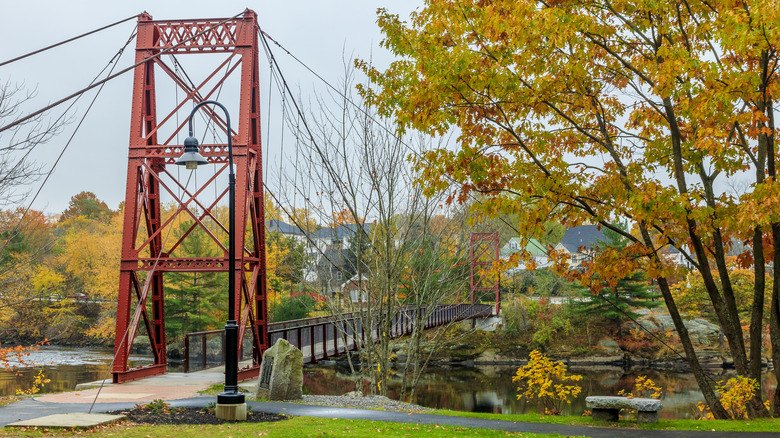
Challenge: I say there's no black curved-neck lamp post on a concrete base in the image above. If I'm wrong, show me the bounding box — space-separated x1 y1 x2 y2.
176 100 246 420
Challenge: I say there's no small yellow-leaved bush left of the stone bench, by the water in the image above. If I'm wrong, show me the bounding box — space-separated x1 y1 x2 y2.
512 350 582 415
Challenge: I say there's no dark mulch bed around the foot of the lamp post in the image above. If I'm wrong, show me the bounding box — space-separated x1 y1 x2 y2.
107 406 288 424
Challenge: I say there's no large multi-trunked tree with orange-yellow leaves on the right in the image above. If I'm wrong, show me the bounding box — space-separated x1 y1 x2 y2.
362 0 780 418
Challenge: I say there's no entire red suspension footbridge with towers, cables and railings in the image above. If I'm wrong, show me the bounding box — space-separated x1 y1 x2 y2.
0 10 498 383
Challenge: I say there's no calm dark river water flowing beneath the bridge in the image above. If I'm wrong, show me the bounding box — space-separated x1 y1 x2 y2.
0 346 776 418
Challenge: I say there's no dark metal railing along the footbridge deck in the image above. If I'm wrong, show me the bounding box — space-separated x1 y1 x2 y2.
184 304 493 373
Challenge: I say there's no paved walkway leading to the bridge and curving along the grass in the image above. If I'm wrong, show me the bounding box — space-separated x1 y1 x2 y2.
0 369 780 438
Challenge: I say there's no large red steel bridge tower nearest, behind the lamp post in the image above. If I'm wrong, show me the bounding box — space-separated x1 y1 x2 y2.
113 10 269 383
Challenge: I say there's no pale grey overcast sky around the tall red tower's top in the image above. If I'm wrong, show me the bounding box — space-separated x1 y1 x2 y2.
0 0 422 213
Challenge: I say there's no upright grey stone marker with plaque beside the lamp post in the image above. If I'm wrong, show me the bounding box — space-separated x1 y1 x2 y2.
256 339 303 400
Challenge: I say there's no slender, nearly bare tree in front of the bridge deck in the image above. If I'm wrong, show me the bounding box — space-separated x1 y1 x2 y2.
286 60 476 394
